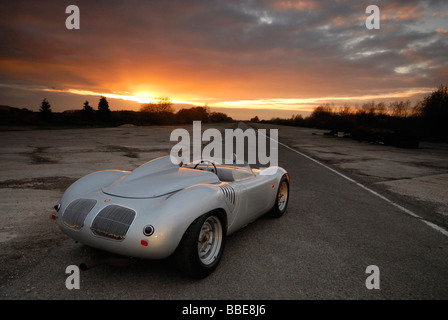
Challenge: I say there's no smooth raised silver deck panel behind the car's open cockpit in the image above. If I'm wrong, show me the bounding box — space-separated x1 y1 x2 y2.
103 157 220 199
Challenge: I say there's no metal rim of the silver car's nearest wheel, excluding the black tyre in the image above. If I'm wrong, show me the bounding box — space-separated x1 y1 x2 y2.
198 216 223 265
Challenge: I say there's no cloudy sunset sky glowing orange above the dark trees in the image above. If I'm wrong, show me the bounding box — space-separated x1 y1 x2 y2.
0 0 448 119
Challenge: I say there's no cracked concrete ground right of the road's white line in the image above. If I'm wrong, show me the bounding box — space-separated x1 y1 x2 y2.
254 124 448 226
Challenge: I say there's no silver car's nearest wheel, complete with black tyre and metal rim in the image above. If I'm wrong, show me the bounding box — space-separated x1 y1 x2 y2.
174 211 226 279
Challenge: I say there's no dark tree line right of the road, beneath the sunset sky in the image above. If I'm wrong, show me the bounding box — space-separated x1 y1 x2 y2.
260 85 448 147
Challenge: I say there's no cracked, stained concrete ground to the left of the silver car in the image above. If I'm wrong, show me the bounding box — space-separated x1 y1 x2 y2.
0 124 238 283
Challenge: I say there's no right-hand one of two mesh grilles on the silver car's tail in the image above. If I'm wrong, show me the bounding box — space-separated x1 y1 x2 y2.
90 205 135 240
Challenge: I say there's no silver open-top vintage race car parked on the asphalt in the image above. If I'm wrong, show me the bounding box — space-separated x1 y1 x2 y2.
53 156 290 278
